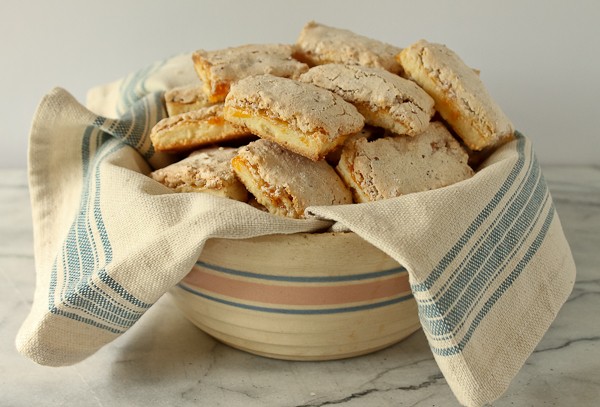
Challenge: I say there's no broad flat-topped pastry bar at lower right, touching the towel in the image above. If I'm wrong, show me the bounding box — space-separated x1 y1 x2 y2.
337 122 474 202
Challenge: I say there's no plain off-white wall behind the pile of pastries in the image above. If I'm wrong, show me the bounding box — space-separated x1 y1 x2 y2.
0 0 600 168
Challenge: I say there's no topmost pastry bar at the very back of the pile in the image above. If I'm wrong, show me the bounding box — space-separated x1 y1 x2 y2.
295 21 402 73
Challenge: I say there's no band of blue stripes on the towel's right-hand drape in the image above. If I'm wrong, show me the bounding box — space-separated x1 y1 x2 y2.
412 135 554 356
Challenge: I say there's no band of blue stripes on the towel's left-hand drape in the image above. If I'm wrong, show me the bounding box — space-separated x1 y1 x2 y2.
48 115 151 334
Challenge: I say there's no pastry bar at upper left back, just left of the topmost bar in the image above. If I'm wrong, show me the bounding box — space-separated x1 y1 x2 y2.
192 44 308 102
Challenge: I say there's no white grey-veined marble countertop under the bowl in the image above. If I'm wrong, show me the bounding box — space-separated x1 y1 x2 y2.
0 166 600 407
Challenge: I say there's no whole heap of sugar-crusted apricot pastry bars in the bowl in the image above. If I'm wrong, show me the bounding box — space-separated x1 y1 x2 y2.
151 22 513 218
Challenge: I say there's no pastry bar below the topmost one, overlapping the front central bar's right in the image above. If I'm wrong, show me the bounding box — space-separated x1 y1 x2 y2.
300 64 434 136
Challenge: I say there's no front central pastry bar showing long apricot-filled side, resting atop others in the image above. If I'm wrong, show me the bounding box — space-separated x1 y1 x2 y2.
224 75 364 160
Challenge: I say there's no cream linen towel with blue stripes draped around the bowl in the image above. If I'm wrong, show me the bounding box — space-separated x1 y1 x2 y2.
16 55 575 406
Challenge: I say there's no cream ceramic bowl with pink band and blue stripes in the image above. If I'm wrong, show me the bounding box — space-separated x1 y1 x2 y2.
171 233 420 360
